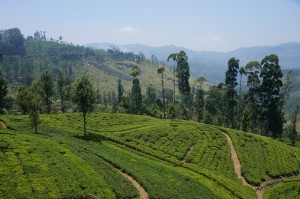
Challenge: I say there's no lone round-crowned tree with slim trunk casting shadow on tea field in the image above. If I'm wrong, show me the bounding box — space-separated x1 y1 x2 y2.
73 77 95 138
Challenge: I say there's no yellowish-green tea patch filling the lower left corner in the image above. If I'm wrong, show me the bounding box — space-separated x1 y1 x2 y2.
0 132 114 198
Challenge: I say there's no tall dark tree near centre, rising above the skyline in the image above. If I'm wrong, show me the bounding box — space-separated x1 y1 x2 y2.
167 51 191 118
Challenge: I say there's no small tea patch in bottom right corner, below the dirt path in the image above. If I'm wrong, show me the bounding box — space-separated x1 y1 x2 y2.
263 178 300 199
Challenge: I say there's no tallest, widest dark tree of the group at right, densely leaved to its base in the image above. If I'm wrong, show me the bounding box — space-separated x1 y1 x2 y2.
260 54 283 138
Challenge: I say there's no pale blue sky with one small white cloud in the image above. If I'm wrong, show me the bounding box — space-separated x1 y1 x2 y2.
0 0 300 52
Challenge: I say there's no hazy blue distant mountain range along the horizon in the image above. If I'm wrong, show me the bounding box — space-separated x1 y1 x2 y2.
86 43 300 83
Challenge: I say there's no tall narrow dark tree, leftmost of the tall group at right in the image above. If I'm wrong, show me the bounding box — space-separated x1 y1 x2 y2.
225 57 240 128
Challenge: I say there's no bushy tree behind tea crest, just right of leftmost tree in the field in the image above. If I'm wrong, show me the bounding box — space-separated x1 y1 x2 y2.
38 70 54 114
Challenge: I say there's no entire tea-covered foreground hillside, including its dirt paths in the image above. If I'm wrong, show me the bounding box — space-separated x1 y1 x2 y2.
0 113 300 199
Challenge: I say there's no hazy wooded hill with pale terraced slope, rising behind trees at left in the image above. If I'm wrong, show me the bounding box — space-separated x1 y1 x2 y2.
0 28 178 95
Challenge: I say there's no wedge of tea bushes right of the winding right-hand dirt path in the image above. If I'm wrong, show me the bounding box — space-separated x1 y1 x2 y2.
225 129 300 185
